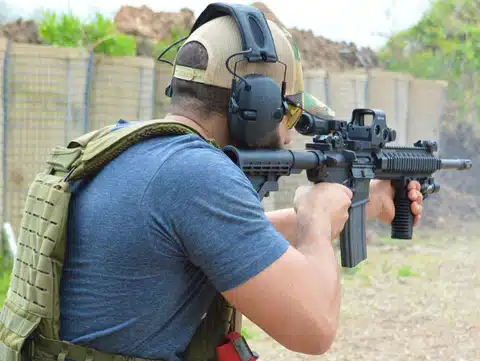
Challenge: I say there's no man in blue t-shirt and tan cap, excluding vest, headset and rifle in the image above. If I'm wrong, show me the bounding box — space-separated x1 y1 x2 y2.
60 7 422 361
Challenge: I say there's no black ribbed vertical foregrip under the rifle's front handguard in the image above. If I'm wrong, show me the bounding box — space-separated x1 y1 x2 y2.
392 182 414 239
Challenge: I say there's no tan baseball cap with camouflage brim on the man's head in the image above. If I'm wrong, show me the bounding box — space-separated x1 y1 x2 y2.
173 16 335 128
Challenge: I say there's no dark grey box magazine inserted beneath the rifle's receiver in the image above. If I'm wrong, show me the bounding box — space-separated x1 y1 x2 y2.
340 200 368 268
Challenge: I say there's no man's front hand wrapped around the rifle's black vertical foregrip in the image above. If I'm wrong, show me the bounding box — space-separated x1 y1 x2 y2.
367 179 423 226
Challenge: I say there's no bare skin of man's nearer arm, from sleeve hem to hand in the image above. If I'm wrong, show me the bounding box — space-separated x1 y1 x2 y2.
223 184 351 355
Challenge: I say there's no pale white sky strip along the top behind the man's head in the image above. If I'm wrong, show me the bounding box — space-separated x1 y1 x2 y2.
4 0 430 49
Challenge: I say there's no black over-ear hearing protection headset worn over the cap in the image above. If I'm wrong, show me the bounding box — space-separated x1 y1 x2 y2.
159 3 288 147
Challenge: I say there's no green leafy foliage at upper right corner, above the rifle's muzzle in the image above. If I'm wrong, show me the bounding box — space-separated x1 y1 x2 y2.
379 0 480 121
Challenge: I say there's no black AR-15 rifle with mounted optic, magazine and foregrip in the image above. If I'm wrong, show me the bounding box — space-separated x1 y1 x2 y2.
223 109 472 268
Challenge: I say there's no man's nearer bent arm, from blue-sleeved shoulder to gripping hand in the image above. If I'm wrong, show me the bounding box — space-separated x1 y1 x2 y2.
158 149 350 354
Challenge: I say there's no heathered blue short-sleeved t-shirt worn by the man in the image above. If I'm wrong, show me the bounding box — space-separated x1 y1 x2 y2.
60 124 288 361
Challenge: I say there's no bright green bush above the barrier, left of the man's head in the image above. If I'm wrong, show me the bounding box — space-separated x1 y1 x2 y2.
39 12 136 56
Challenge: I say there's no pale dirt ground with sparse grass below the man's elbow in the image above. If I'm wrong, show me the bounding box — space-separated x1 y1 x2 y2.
244 229 480 361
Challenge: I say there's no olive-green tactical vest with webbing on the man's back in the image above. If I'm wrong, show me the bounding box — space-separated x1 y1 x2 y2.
0 120 249 361
